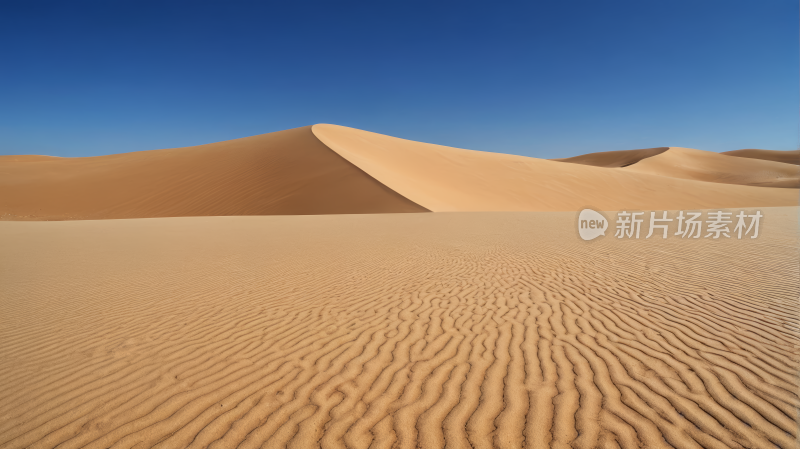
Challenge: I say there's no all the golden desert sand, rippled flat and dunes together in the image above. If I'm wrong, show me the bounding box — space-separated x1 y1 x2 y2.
0 125 800 449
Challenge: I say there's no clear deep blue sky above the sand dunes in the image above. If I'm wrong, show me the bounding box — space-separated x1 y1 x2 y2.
0 0 800 158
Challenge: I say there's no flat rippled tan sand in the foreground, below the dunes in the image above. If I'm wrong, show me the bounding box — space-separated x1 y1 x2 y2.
0 208 800 448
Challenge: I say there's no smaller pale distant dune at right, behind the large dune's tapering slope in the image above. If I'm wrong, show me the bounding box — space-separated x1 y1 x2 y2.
621 147 800 189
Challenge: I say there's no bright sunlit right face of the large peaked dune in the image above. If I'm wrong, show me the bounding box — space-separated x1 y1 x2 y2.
312 124 797 212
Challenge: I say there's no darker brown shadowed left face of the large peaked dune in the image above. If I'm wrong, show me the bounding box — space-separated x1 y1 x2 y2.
0 127 425 220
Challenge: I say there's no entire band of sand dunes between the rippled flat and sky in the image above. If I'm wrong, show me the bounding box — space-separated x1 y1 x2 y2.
0 124 800 220
